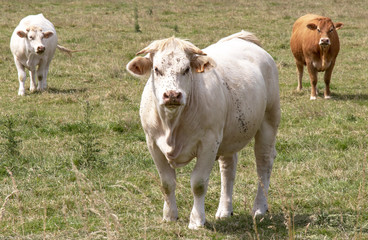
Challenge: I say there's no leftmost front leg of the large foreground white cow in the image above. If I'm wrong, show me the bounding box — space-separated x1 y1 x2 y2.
147 141 178 222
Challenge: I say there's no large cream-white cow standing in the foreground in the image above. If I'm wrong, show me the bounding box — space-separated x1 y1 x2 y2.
127 31 280 229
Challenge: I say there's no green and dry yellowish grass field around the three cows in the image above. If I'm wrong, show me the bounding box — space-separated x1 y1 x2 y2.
0 0 368 239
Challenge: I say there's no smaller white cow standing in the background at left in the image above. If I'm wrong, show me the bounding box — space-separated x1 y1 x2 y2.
10 14 73 95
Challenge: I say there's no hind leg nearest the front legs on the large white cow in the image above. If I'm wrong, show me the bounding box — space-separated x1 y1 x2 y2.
216 153 238 218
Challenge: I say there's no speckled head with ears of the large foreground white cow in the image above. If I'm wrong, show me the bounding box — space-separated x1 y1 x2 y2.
126 37 215 109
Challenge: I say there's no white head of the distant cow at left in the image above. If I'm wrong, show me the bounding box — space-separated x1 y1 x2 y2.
17 26 54 55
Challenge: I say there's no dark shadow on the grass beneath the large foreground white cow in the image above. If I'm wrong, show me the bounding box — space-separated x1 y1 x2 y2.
205 214 313 238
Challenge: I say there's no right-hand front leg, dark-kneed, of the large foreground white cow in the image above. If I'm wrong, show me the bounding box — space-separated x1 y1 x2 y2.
188 141 218 229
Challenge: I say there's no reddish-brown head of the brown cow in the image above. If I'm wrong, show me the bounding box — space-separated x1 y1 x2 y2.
307 18 343 47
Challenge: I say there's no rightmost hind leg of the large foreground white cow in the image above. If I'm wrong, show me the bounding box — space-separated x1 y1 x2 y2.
253 111 280 216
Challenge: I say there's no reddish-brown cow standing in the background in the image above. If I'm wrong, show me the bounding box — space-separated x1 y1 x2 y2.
290 14 343 100
